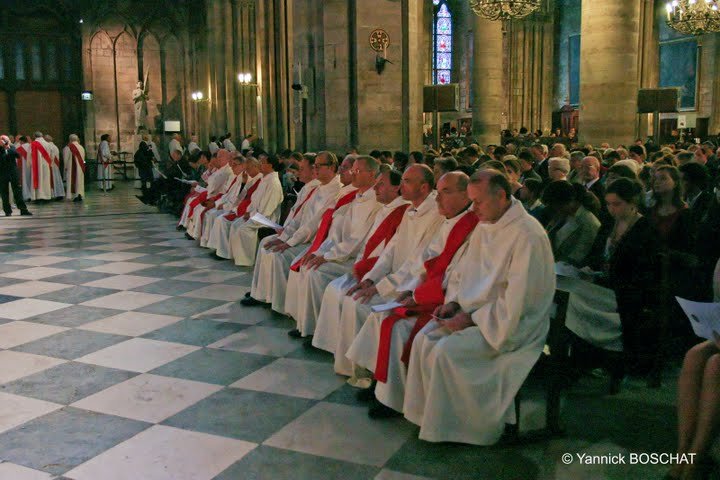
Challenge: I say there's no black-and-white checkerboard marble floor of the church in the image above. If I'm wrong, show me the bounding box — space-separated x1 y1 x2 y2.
0 189 675 480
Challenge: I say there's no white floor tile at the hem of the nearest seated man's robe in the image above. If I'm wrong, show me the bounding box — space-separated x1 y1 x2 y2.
263 402 414 467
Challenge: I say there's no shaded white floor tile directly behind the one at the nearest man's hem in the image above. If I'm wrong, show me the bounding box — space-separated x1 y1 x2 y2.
230 358 345 400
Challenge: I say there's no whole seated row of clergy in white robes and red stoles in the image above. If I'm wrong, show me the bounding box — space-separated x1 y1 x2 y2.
174 150 555 445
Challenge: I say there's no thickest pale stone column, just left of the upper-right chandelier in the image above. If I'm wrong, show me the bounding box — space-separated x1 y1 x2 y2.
578 0 641 145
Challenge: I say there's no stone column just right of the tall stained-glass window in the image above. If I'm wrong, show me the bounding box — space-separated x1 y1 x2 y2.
472 16 505 147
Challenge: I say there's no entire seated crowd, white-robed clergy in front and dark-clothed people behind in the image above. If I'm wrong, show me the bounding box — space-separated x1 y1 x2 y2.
163 139 720 478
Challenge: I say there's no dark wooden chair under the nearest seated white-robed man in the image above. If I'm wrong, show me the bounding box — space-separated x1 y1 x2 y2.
501 290 570 444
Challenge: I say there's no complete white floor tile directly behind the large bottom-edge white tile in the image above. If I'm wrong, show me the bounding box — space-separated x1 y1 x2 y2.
71 374 223 423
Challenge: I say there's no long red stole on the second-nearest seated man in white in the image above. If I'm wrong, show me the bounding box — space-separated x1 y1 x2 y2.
375 212 480 383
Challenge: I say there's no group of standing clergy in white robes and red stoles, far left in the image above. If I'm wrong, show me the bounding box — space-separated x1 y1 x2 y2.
2 132 86 201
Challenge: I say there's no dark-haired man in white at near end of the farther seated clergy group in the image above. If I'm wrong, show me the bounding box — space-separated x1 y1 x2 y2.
229 155 283 267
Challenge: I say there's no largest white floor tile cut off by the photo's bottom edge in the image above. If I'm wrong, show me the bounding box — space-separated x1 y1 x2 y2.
65 425 256 480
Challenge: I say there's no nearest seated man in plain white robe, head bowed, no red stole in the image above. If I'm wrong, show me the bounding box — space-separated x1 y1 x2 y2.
403 170 555 445
